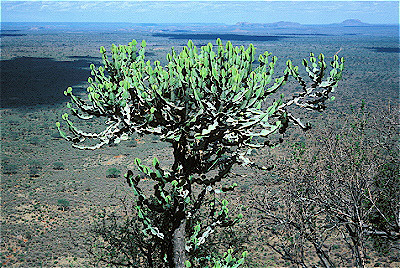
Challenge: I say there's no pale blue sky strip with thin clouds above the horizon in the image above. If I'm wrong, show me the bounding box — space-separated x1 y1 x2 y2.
1 0 399 24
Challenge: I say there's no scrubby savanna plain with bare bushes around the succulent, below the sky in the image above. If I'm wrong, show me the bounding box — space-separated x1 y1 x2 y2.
0 20 400 267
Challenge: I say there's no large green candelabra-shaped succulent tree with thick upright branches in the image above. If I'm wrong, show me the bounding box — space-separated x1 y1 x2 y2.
57 39 344 267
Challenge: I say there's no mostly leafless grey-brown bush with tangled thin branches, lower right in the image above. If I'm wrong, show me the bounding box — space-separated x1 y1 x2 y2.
253 104 400 267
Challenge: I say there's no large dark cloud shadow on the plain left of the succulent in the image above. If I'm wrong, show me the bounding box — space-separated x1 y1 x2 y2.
0 57 97 108
